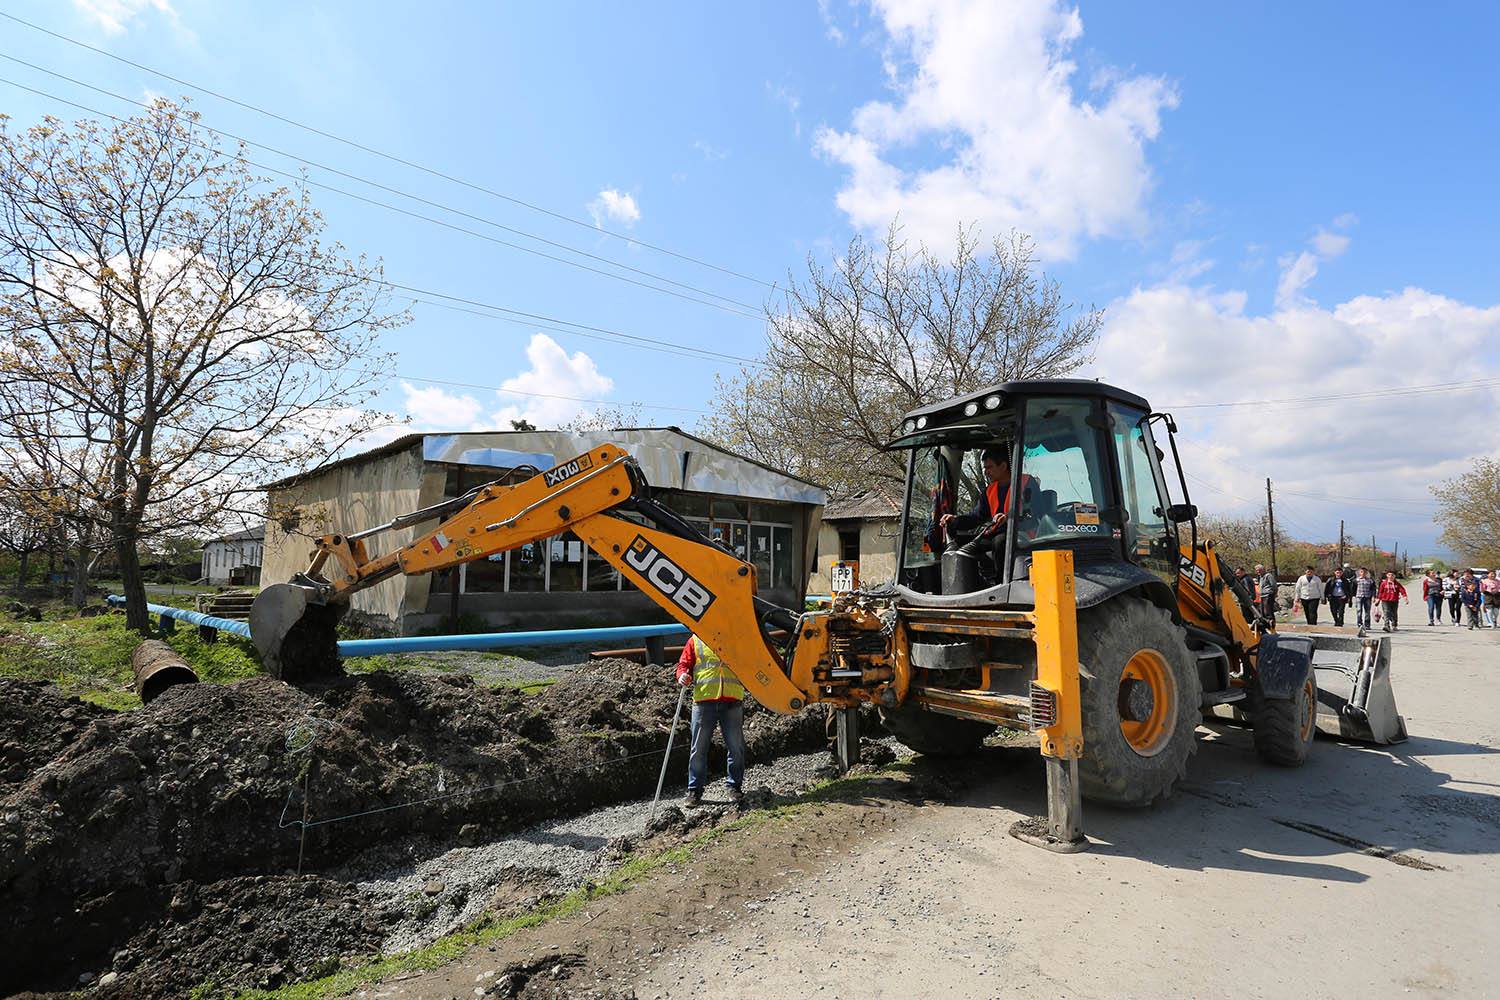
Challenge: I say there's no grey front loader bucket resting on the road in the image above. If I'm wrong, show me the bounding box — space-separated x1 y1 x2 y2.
1310 634 1407 744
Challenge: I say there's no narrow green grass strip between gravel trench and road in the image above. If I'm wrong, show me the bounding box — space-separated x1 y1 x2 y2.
220 765 908 1000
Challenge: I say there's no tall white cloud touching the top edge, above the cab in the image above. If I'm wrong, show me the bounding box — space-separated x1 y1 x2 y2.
818 0 1178 258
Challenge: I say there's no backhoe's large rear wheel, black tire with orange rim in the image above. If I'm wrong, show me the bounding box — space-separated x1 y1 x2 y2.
1079 597 1203 807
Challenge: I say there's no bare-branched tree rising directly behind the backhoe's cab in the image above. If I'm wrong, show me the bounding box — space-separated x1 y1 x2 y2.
704 225 1103 492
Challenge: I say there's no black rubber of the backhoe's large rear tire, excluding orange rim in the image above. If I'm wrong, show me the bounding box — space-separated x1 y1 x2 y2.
1079 597 1203 807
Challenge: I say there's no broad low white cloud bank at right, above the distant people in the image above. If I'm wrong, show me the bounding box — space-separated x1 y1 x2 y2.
1089 285 1500 552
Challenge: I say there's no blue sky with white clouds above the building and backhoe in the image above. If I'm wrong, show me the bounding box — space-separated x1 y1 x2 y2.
0 0 1500 555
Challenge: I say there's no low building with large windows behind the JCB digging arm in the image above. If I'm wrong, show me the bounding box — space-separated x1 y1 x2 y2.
263 427 827 634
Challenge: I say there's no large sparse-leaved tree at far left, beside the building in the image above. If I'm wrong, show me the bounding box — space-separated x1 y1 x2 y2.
0 100 405 630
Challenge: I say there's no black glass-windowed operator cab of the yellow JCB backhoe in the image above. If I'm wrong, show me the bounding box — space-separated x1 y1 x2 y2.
888 379 1193 604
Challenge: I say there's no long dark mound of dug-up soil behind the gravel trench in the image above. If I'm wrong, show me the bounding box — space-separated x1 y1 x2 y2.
0 661 824 996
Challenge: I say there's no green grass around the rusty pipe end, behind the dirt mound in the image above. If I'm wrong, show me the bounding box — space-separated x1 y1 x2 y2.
0 615 261 711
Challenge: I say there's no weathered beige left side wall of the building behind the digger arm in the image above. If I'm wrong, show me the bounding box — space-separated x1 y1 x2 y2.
261 441 429 621
